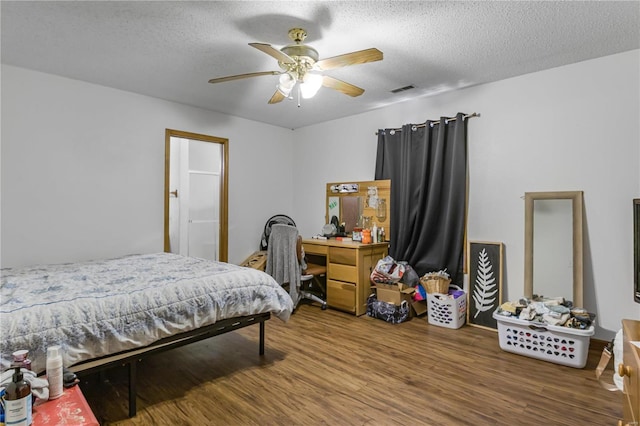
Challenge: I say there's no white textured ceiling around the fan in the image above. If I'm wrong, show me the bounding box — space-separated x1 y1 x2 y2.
1 1 640 128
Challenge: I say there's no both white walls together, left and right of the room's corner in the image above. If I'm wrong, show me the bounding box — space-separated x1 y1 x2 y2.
1 50 640 339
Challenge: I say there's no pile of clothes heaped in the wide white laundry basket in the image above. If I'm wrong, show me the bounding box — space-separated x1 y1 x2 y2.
496 295 596 330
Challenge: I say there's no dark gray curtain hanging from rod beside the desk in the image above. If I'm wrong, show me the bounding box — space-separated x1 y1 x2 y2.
375 113 467 287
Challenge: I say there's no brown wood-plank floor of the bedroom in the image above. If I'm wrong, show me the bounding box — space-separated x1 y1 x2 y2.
81 305 622 426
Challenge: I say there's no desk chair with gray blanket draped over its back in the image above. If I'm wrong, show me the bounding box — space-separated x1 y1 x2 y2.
265 224 327 310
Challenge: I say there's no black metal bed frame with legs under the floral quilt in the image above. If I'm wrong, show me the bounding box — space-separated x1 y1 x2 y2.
69 312 271 417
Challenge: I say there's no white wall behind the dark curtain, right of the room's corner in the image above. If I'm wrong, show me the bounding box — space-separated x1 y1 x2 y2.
294 50 640 339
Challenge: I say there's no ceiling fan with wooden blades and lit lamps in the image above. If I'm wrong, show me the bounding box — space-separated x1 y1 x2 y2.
209 28 382 104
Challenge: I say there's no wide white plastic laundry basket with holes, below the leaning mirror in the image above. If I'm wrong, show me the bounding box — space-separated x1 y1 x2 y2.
493 312 595 368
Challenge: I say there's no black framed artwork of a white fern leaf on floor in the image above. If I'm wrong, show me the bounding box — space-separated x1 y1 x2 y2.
467 241 503 330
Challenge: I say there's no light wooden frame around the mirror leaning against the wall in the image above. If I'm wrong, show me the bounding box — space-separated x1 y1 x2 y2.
524 191 584 307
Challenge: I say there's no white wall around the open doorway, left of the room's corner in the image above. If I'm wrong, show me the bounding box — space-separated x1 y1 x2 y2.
1 65 294 267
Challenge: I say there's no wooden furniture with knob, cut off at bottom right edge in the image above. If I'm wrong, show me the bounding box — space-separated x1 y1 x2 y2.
615 320 640 426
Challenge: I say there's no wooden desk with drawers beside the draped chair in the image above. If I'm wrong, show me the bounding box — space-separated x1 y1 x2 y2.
302 239 389 315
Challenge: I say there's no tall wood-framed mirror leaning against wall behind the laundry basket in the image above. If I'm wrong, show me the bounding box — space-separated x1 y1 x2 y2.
524 191 583 307
